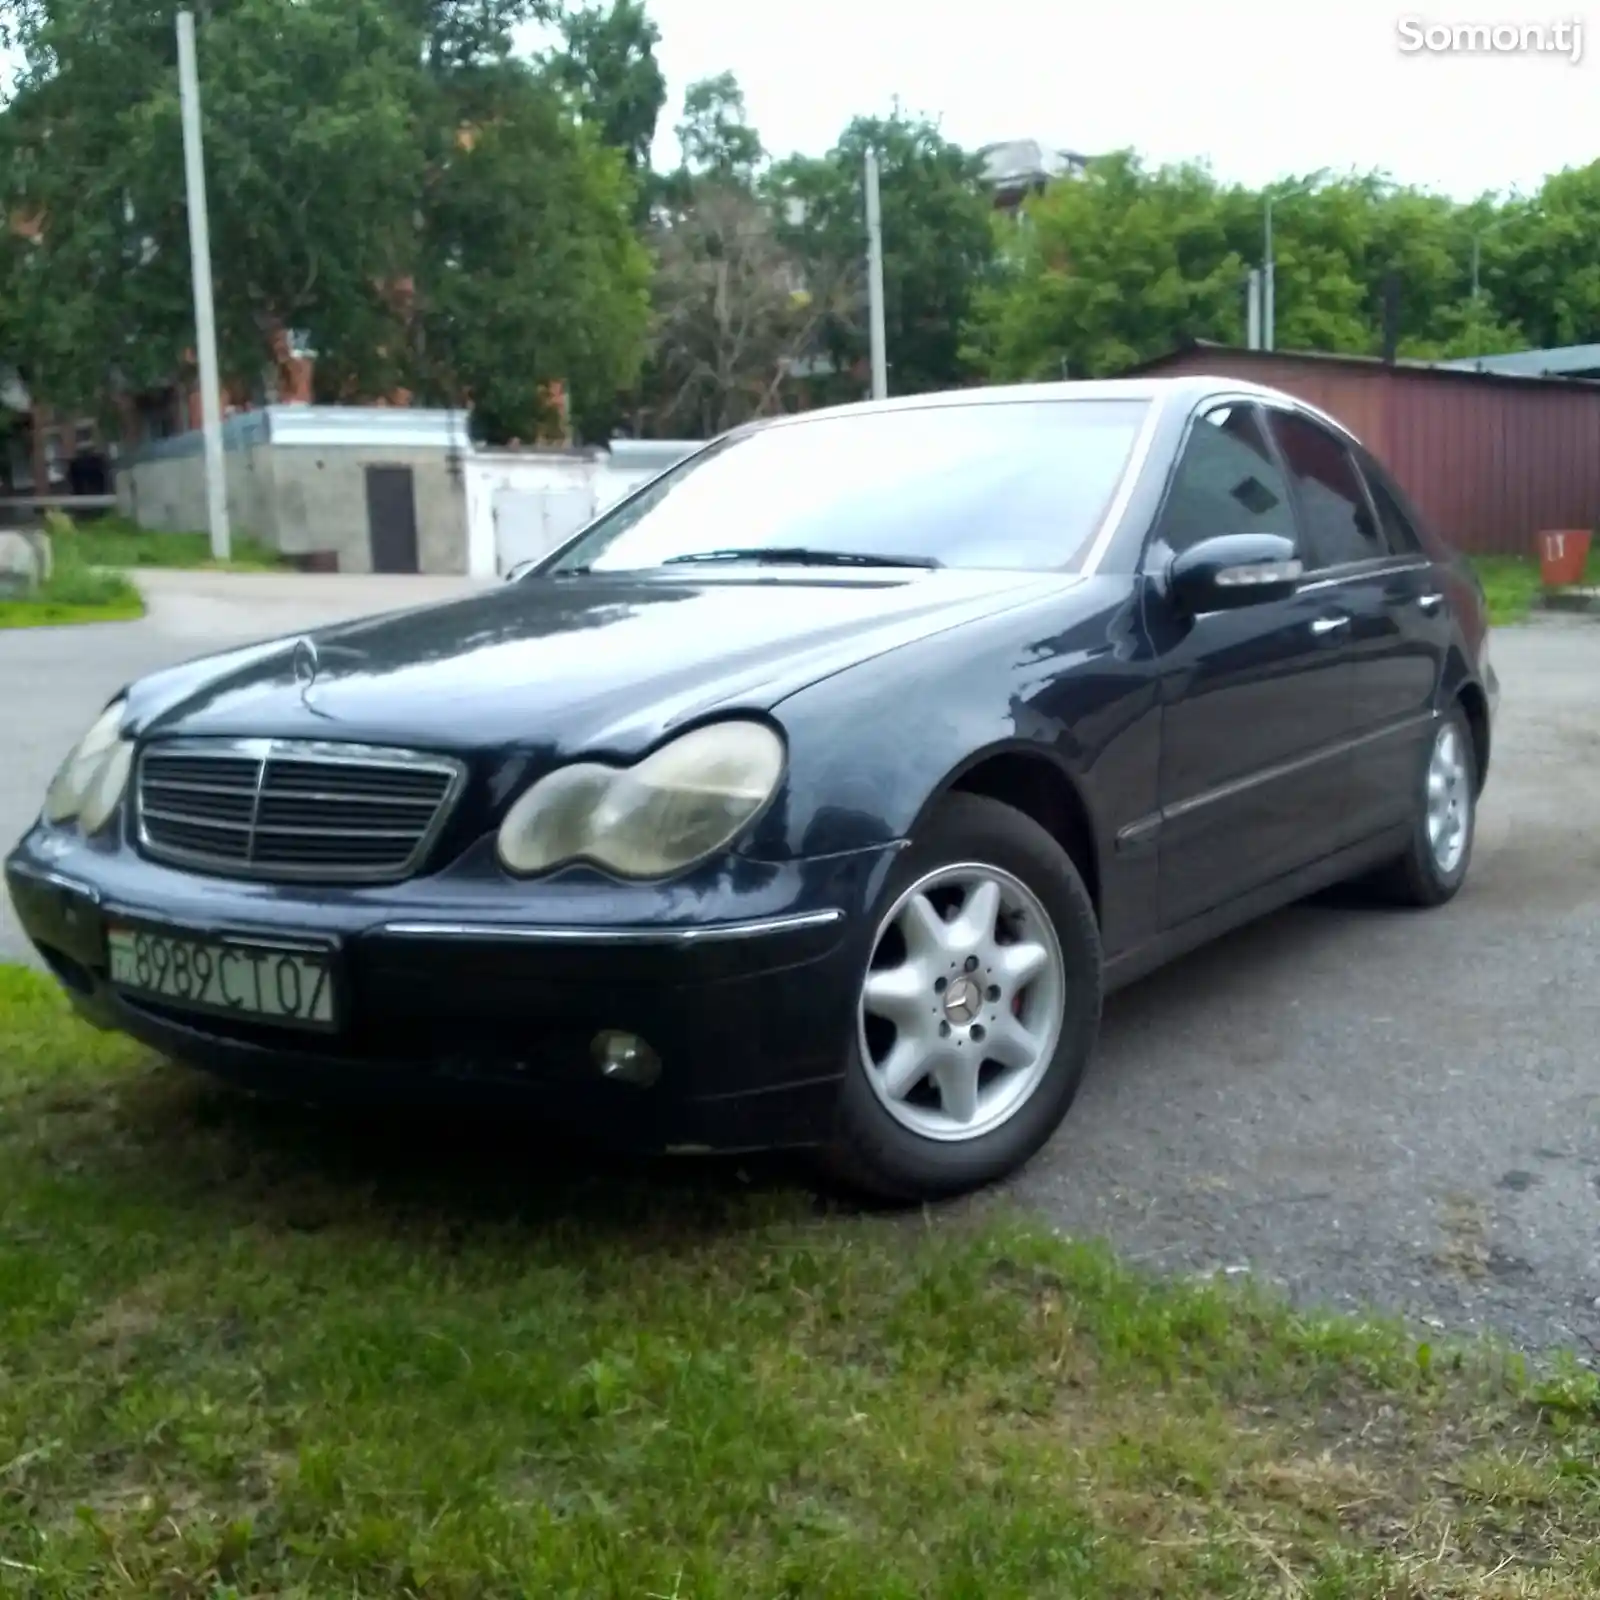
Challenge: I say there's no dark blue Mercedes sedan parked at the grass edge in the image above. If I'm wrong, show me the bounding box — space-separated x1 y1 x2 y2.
6 379 1496 1197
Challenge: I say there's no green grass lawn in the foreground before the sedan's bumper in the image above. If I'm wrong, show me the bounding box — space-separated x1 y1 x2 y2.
0 968 1600 1600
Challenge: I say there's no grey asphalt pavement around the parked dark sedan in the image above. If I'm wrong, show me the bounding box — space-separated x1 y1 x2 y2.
9 573 1600 1352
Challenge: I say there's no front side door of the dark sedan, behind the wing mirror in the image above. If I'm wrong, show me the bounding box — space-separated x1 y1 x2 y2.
1144 402 1352 928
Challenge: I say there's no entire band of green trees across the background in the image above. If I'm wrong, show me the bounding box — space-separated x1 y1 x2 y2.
0 0 1600 457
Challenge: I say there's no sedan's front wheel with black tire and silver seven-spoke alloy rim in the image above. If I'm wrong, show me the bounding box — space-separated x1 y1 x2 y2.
824 794 1102 1202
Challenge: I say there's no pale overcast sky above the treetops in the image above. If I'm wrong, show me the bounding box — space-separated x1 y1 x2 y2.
540 0 1600 197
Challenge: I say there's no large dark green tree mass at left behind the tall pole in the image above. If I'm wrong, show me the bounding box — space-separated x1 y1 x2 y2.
0 0 648 434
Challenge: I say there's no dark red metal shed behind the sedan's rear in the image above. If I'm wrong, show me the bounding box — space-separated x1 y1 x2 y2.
1130 341 1600 555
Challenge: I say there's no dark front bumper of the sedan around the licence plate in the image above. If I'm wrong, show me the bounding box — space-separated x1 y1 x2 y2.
5 826 894 1150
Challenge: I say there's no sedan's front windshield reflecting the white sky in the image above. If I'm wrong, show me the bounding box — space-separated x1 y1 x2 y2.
544 400 1149 573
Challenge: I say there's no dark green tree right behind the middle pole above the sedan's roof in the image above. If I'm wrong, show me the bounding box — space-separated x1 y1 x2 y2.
766 110 995 398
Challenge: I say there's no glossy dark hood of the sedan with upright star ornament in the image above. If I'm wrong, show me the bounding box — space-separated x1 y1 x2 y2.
130 570 1077 757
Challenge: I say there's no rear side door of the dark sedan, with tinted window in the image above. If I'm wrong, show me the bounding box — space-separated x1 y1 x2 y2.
1270 411 1450 843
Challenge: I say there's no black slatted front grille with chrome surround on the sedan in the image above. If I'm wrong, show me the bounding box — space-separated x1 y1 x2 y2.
134 739 464 883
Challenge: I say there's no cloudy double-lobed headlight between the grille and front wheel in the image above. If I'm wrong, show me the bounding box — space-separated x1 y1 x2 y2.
499 722 784 878
